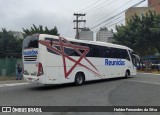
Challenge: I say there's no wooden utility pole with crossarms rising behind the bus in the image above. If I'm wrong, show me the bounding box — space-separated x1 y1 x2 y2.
73 13 86 39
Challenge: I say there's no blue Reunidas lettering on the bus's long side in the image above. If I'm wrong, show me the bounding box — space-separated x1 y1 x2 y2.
105 59 125 66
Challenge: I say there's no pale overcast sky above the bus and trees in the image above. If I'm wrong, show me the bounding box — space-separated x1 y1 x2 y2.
0 0 147 38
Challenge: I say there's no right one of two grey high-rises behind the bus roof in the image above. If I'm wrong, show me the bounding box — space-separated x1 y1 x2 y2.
96 27 113 43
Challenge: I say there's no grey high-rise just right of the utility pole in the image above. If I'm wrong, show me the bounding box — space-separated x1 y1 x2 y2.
79 27 93 41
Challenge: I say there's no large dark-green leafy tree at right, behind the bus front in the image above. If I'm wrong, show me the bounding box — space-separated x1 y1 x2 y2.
114 11 160 56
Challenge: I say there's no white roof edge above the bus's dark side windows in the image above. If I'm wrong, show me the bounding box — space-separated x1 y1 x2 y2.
39 34 133 51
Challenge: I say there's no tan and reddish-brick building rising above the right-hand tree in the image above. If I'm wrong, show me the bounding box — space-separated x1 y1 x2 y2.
125 0 160 22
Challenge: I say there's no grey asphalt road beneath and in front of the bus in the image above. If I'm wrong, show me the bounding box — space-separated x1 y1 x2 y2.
0 74 160 115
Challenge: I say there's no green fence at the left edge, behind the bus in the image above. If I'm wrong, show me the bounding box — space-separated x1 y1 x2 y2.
0 56 22 76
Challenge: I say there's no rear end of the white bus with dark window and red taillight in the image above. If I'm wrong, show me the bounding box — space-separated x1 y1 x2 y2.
22 34 45 84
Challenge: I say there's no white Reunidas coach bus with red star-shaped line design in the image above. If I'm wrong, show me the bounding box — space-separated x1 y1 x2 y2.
22 34 137 85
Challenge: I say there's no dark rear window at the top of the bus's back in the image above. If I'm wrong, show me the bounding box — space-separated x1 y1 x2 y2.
23 35 38 49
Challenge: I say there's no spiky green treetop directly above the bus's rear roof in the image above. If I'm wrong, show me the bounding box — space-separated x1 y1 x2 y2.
22 24 59 37
